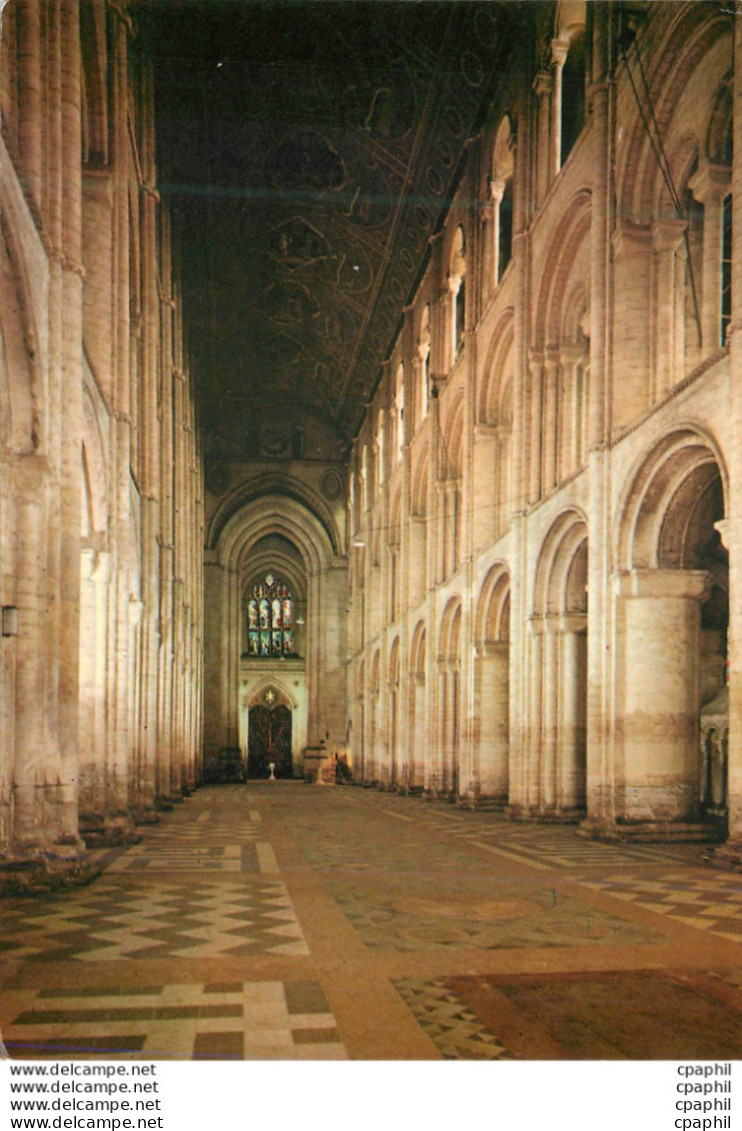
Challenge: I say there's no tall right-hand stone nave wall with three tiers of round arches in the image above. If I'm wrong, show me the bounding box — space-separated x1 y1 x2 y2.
348 3 742 854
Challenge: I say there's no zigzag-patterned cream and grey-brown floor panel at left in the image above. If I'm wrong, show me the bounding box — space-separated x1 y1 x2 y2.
0 880 308 962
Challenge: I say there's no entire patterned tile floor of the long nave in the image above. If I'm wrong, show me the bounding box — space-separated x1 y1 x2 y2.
0 782 742 1060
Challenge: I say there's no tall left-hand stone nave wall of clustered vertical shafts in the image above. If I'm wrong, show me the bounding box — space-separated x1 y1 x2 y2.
0 0 204 882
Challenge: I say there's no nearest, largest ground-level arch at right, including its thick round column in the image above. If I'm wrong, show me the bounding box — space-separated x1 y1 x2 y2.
616 425 728 827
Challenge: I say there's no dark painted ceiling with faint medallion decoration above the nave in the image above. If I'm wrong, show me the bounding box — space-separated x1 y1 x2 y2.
138 0 528 459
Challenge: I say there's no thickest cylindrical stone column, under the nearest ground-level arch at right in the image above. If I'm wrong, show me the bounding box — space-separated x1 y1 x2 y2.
616 569 710 824
